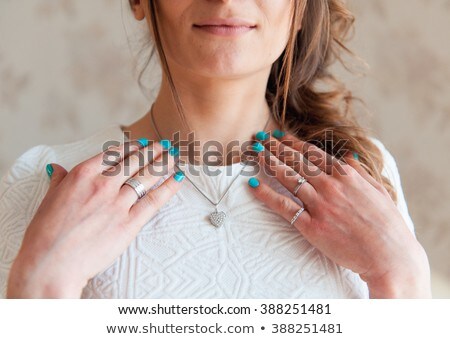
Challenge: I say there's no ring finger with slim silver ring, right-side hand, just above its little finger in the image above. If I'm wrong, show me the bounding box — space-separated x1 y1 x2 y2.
258 152 317 206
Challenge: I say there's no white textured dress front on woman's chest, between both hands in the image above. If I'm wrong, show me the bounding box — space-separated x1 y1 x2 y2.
84 179 367 298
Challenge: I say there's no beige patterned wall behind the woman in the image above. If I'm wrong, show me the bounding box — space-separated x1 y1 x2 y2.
0 0 450 297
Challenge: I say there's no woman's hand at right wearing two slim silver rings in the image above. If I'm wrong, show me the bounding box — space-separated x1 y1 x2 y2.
252 134 431 298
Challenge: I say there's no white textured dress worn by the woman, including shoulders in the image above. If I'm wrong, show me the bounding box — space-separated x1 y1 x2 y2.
0 124 414 298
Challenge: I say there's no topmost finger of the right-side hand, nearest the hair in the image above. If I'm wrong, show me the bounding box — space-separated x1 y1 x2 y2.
272 133 345 175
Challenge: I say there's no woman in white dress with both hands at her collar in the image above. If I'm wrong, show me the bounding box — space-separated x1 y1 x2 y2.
0 0 431 298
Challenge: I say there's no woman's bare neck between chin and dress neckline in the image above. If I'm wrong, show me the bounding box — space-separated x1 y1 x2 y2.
121 74 279 165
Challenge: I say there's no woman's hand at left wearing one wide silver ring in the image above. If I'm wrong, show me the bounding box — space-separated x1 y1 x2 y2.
7 141 184 298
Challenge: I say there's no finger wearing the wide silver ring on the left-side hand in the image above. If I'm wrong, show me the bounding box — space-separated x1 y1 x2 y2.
119 152 175 206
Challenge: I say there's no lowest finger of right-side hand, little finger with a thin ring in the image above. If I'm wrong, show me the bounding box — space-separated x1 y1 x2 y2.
249 178 311 233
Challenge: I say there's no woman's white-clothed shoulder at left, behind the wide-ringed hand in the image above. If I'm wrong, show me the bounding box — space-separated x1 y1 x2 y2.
0 124 123 297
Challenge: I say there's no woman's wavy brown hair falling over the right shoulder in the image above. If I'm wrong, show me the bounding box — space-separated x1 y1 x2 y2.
130 0 397 202
